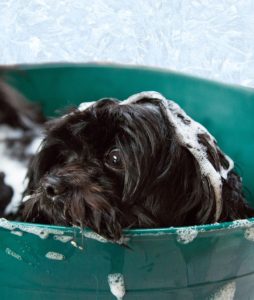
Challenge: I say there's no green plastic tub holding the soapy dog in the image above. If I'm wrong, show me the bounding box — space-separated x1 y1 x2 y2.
0 64 254 300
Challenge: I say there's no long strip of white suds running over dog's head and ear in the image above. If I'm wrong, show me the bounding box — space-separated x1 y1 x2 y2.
120 91 234 222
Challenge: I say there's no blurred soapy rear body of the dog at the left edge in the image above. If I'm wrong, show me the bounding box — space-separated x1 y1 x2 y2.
0 71 45 217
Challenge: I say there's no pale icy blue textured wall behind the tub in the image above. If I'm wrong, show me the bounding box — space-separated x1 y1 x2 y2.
0 0 254 87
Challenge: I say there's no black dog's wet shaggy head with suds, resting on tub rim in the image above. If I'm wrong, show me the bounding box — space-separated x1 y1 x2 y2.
21 92 254 241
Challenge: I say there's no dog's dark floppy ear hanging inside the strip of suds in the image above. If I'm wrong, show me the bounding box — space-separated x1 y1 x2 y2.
137 142 216 227
